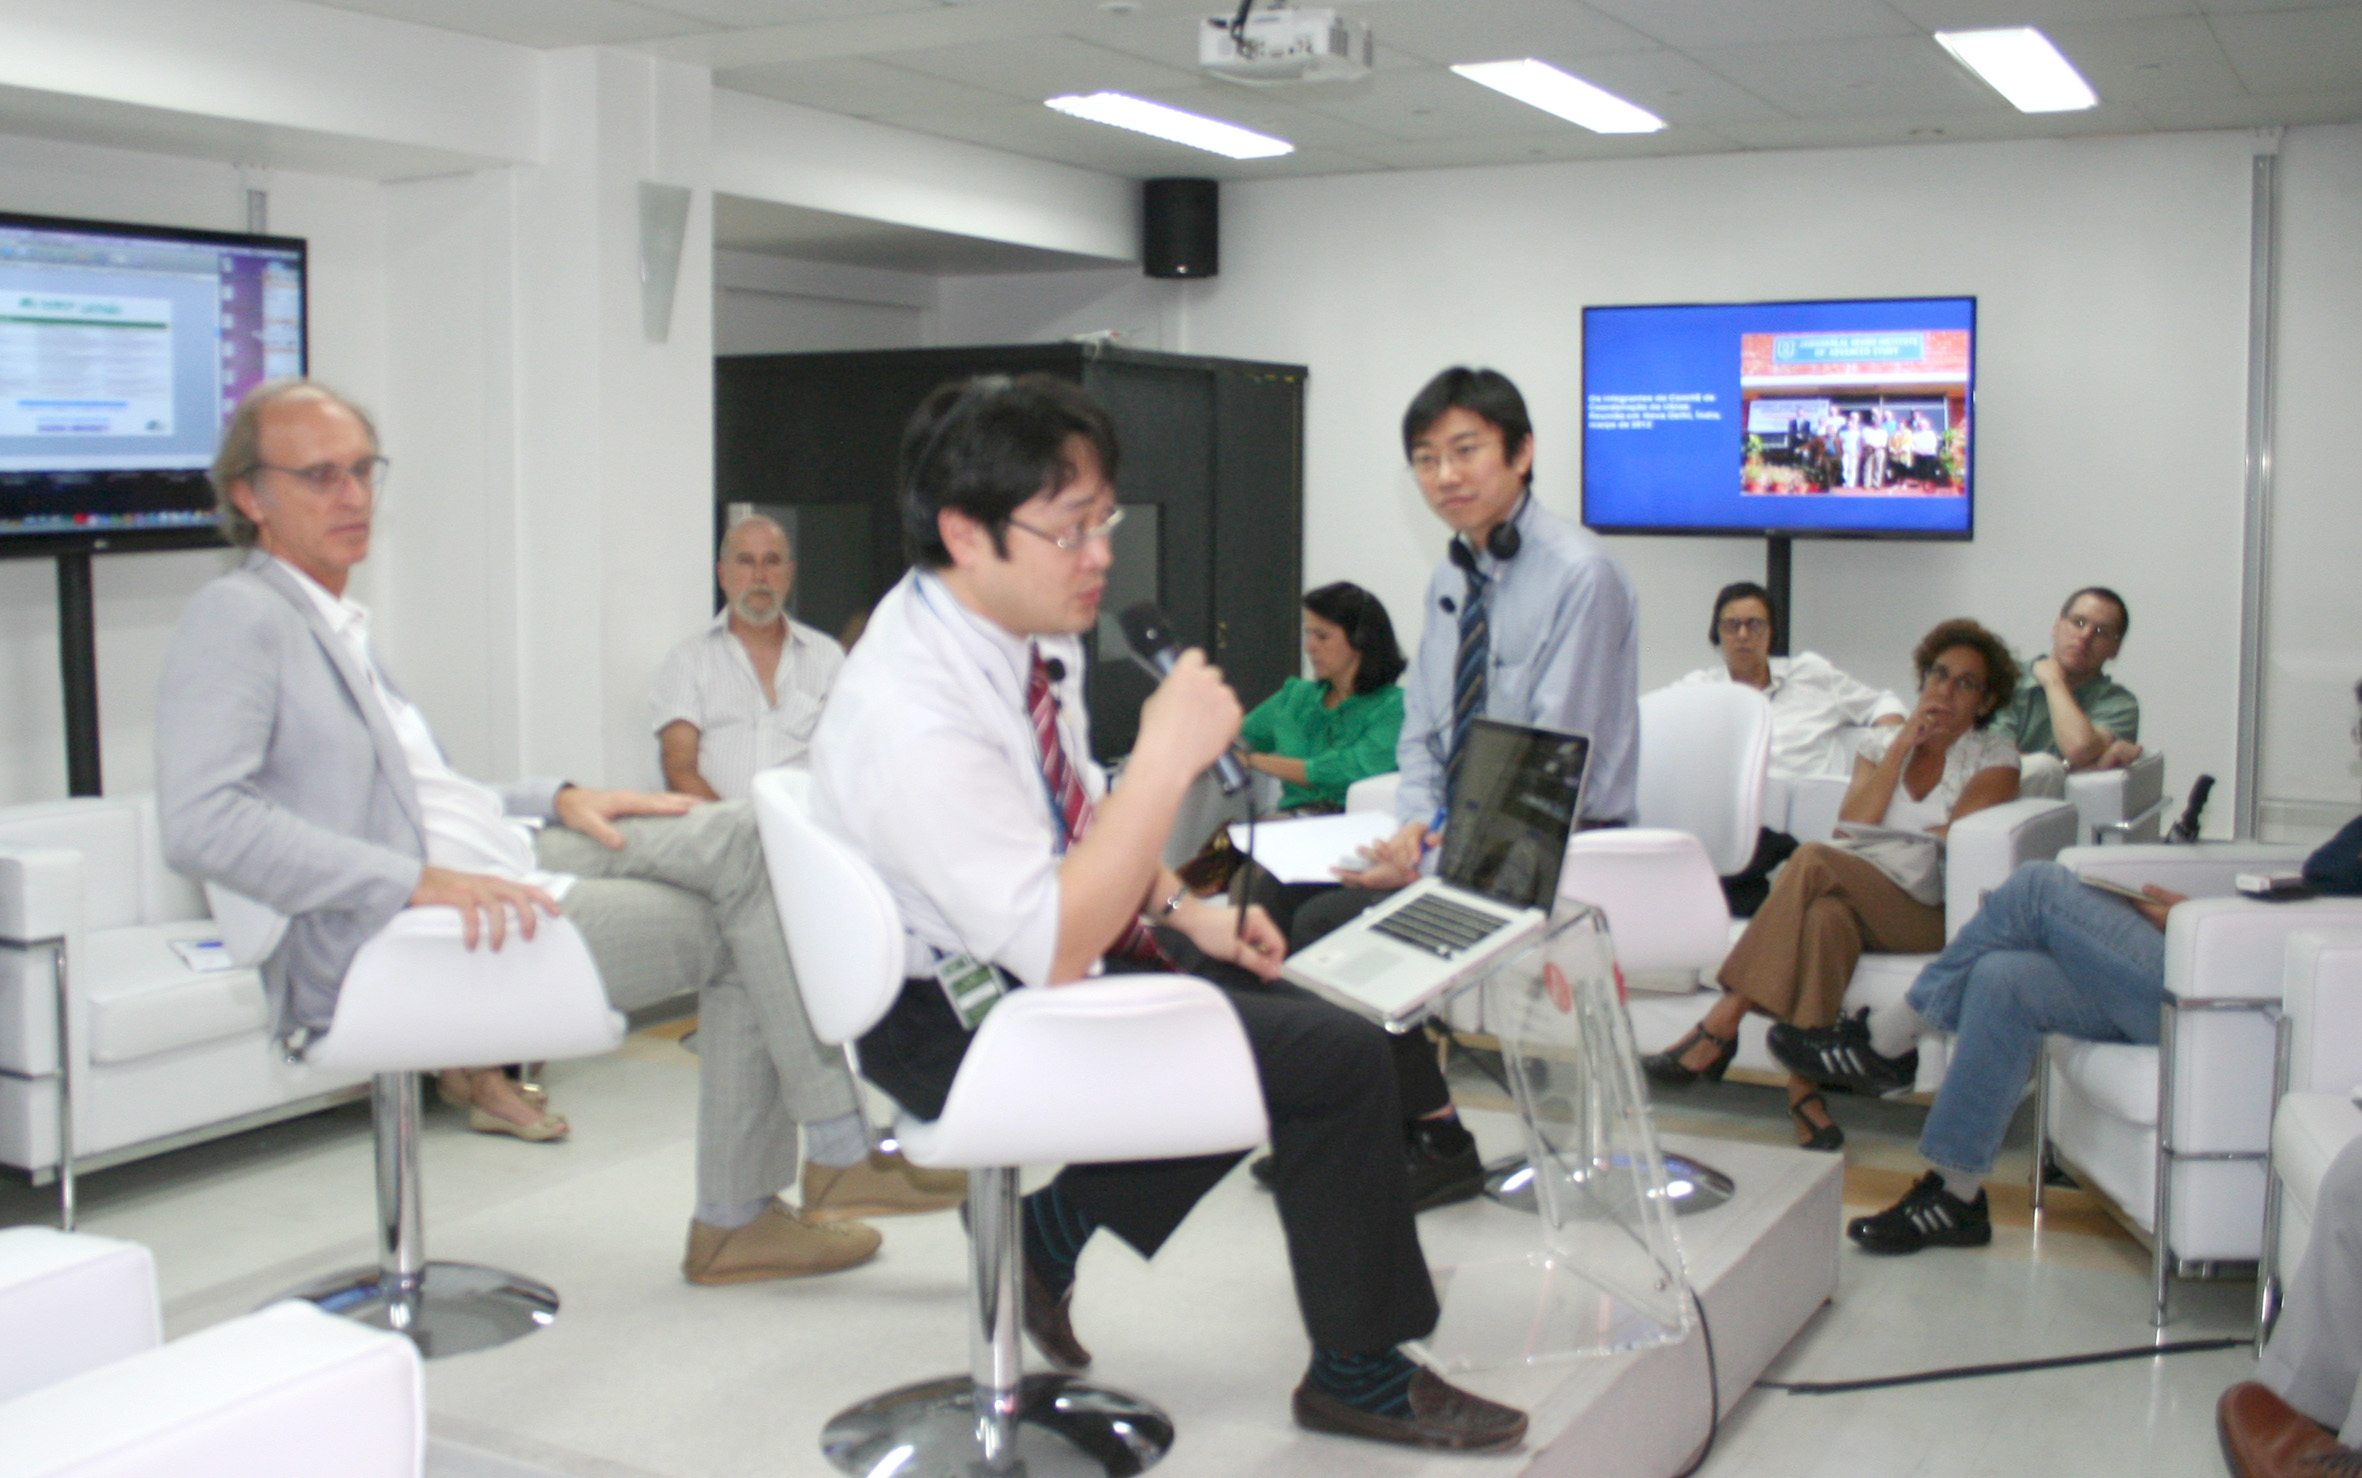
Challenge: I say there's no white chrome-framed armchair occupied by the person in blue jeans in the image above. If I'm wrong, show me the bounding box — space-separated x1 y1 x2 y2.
2034 843 2362 1325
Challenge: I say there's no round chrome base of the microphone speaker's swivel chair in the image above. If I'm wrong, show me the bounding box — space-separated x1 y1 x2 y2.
820 1374 1174 1478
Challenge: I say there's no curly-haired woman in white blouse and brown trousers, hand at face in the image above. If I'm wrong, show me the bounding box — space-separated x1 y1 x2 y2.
1644 619 2017 1150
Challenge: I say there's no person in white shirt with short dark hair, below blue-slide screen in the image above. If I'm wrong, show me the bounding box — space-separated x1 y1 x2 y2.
1682 581 1906 918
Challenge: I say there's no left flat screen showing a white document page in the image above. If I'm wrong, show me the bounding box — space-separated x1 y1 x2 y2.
0 215 305 557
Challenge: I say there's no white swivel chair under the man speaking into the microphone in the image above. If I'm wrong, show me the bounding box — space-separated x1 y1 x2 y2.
753 774 1268 1478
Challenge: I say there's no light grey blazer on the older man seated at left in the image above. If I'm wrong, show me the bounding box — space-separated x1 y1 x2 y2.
156 550 562 1034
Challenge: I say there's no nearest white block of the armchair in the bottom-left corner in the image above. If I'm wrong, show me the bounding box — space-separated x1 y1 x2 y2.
0 1303 425 1478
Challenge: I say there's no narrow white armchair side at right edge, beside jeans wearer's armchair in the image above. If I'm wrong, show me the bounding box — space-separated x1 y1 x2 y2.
2256 928 2362 1341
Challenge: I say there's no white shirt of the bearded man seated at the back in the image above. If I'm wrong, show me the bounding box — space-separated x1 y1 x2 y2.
647 609 846 800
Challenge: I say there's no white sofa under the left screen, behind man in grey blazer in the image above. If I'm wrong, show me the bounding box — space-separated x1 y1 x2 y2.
0 796 366 1181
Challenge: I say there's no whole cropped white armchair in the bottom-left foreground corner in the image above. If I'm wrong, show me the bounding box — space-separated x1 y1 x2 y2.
0 1228 425 1478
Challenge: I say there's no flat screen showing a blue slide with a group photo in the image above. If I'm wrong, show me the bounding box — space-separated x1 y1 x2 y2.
1583 297 1977 538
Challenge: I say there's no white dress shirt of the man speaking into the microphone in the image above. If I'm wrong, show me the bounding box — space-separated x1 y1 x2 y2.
813 569 1081 985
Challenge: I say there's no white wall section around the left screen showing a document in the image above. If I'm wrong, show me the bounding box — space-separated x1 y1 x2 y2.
0 137 385 805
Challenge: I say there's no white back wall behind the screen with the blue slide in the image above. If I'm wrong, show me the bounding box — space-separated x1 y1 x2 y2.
938 130 2305 829
